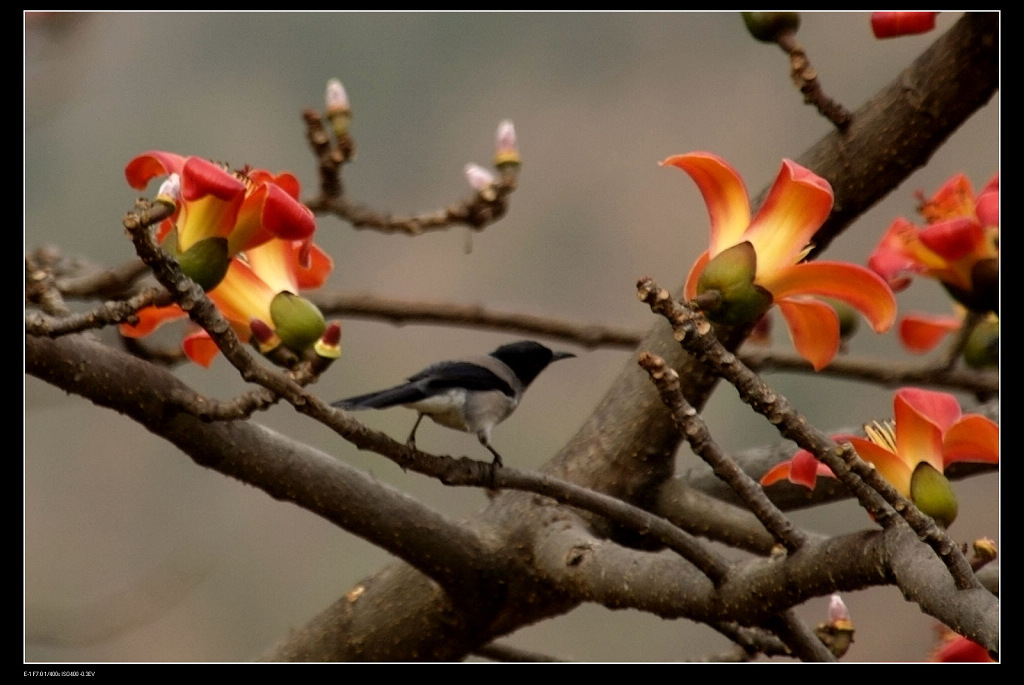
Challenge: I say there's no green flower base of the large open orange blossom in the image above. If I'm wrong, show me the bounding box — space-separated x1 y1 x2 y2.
697 242 772 326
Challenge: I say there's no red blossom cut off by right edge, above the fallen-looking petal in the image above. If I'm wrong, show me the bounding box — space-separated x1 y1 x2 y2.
867 174 999 312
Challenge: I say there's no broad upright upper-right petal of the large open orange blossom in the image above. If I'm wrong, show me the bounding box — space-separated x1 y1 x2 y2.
743 160 833 273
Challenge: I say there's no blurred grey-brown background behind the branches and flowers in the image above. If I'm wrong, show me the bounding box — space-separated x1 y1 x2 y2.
25 12 999 661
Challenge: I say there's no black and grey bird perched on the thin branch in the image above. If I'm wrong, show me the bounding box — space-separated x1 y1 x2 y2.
331 340 575 467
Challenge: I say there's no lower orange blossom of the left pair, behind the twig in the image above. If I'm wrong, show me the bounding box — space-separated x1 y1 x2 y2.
121 240 333 367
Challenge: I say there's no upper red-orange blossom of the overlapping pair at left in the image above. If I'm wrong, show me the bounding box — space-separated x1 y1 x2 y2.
125 151 316 290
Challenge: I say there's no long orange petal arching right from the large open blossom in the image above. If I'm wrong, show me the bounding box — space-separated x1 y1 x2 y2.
758 260 896 333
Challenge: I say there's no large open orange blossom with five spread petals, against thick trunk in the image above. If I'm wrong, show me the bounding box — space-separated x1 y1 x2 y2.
662 152 896 370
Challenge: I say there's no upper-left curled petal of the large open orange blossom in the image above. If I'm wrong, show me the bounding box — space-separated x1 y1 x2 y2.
662 153 751 257
